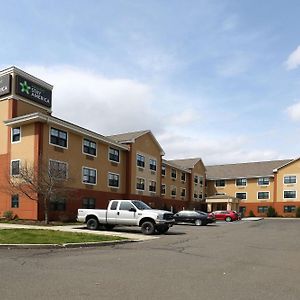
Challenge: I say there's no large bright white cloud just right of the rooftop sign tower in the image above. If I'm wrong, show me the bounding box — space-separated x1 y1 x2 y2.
25 66 161 135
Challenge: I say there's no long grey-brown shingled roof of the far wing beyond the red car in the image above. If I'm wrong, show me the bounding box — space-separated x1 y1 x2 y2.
206 159 292 179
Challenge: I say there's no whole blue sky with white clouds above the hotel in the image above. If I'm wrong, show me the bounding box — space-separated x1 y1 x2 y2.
0 0 300 165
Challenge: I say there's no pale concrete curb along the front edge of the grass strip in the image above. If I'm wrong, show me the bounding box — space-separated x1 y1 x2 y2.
0 240 140 249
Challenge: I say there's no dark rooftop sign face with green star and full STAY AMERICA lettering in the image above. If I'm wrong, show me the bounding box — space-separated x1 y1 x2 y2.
16 75 52 107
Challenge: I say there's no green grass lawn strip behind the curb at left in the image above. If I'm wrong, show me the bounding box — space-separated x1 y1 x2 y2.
0 229 125 244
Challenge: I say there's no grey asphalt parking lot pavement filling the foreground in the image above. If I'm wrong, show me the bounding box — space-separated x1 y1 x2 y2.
0 220 300 300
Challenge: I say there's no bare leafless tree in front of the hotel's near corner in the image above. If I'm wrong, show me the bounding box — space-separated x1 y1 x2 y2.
9 160 70 224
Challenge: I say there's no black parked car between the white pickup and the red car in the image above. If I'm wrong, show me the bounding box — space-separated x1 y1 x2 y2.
174 210 216 226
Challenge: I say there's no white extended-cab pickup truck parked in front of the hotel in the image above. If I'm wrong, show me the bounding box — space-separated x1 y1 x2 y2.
77 200 175 234
